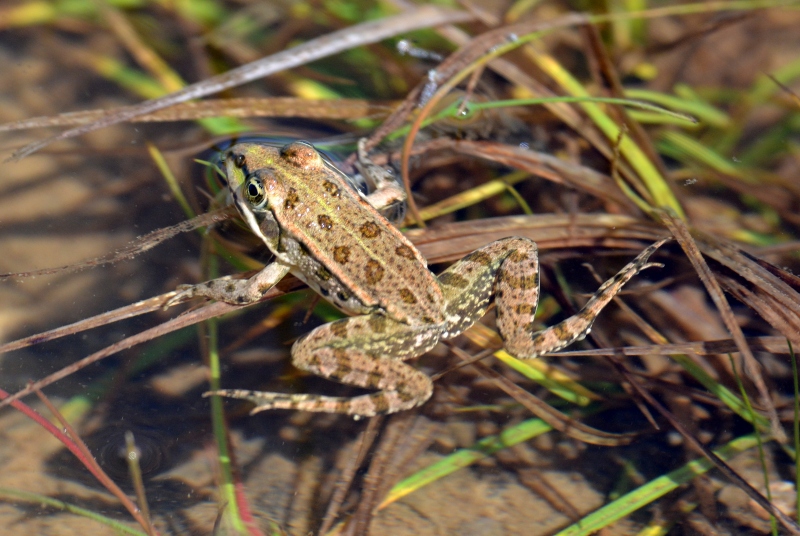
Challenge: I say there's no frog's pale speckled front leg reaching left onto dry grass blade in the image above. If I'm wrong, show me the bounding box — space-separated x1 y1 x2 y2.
167 261 290 307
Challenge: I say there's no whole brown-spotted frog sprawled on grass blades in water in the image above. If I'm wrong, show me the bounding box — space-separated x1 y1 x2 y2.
179 141 668 418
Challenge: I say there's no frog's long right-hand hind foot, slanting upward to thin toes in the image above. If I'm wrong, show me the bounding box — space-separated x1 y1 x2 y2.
506 238 670 359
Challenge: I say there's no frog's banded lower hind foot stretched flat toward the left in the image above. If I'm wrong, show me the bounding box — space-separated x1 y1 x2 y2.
203 389 430 417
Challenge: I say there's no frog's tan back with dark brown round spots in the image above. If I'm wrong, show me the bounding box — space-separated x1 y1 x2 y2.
262 143 443 323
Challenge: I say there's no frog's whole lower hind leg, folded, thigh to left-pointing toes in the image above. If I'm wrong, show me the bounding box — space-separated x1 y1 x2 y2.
204 314 440 417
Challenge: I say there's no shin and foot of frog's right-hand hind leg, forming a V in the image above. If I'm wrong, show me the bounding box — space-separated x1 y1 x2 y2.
496 239 669 359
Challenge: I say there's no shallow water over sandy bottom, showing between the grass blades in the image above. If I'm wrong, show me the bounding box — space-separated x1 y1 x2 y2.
0 5 800 535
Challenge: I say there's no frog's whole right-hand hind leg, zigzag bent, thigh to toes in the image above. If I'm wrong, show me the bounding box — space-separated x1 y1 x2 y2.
438 237 668 359
